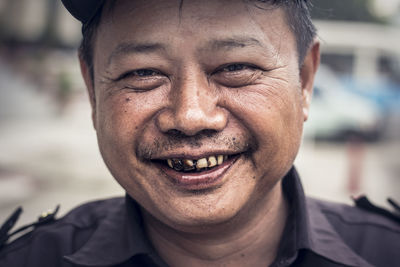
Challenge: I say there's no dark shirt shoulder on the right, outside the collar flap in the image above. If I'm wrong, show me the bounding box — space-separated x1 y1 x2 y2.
307 198 400 266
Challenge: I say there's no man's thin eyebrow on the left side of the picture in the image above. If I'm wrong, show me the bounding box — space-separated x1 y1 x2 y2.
108 43 166 64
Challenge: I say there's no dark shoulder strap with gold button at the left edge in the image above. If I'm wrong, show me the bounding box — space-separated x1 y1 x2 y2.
0 205 60 249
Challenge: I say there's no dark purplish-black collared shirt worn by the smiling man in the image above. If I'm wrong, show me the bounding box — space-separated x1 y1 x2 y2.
0 168 400 267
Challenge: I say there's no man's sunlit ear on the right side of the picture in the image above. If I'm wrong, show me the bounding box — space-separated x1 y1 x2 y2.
300 39 320 121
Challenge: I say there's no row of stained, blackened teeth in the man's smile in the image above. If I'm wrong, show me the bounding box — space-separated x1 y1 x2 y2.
167 155 228 171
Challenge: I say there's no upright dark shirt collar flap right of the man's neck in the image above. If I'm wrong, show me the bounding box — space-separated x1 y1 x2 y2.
275 167 372 266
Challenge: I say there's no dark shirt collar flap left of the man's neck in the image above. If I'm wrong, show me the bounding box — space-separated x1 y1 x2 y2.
64 195 159 267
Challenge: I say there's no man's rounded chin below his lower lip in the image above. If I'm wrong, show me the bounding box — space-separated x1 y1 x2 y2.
142 171 257 232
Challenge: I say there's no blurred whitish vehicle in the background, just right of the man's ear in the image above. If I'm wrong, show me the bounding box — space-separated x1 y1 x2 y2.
304 65 387 141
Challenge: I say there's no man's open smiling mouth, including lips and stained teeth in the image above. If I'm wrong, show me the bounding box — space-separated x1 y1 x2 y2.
152 154 241 190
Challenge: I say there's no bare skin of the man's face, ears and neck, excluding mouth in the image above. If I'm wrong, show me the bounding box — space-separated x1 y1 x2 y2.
81 0 319 266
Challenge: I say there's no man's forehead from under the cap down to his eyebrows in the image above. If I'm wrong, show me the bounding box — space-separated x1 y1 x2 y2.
95 0 297 68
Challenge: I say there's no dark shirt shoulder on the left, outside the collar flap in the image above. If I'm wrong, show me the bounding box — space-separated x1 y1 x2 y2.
0 198 124 267
